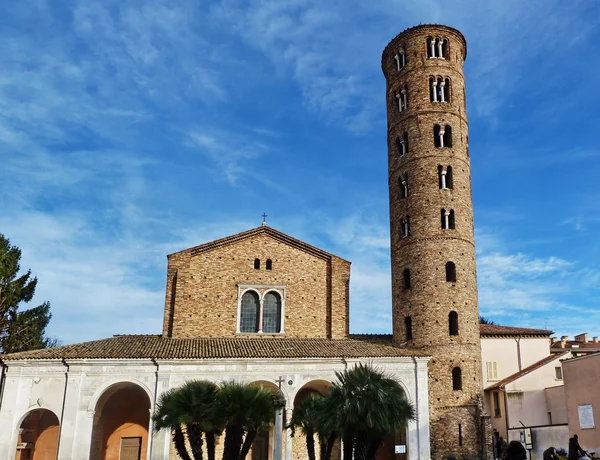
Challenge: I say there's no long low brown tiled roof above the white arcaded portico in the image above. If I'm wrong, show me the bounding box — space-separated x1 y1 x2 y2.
0 335 427 362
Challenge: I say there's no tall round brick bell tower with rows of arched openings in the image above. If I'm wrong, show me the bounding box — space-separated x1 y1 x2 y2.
382 25 487 459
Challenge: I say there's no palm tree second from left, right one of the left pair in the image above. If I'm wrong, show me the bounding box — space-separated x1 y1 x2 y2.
217 382 277 460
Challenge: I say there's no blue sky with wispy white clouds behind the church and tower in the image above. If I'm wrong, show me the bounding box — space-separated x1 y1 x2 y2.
0 0 600 343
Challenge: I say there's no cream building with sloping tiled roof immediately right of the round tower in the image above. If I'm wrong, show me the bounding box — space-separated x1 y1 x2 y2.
481 325 571 460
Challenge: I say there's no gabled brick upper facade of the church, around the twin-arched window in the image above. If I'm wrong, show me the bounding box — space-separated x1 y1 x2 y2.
163 226 350 338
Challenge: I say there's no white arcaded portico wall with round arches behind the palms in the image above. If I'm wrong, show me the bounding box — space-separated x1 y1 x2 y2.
0 357 430 460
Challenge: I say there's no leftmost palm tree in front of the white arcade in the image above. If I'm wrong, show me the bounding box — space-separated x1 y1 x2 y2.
153 380 223 460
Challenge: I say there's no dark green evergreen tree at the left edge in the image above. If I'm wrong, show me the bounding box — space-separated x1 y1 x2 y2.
0 234 57 353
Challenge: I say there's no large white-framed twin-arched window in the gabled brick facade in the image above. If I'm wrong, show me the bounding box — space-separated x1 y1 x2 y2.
238 285 285 334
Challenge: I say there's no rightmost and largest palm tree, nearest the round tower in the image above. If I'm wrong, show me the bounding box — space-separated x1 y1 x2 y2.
327 364 415 460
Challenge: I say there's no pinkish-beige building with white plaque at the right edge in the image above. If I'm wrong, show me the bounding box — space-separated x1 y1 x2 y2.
563 353 600 453
